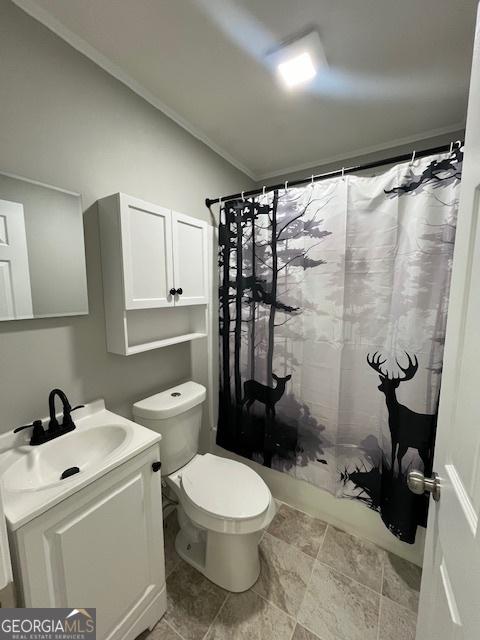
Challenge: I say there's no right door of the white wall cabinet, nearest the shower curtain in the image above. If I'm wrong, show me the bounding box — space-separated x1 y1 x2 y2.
172 211 208 306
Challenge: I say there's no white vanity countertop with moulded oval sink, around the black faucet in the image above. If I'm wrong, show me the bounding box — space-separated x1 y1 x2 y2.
0 400 161 531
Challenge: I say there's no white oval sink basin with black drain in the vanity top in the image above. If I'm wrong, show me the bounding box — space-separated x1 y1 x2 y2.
2 425 128 493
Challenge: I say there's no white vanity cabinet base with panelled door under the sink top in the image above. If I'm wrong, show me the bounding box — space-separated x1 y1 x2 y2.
11 445 166 640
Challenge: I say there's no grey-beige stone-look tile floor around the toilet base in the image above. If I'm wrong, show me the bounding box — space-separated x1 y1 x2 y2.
147 504 421 640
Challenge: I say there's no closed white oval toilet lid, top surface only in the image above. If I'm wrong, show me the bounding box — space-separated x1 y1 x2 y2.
181 453 271 520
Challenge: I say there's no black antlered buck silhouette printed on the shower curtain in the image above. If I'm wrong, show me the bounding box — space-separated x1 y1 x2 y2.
367 352 436 474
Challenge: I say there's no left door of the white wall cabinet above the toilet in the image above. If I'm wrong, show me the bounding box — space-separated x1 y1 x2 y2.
120 194 174 309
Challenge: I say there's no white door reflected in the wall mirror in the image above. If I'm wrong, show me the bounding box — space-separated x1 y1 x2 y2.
0 200 33 320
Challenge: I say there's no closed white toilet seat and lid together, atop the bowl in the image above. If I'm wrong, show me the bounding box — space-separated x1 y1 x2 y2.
168 453 275 533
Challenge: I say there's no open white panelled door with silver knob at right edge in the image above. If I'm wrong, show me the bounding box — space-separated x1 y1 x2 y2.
416 6 480 640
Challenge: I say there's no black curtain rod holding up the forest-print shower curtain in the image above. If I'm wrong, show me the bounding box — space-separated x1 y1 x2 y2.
205 140 463 208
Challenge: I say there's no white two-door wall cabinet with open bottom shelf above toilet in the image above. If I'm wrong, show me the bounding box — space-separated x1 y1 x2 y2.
99 193 210 355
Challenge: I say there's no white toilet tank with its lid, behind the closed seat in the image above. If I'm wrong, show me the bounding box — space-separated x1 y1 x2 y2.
133 381 207 475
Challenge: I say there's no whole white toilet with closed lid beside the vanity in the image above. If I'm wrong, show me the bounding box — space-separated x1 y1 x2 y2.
133 382 275 592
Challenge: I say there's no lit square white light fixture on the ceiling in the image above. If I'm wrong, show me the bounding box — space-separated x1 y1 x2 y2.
267 30 327 89
